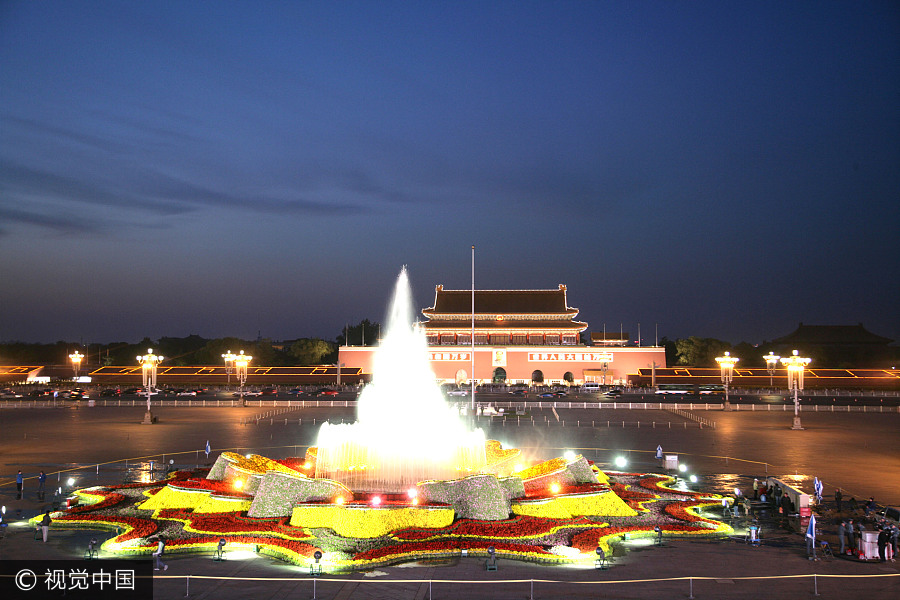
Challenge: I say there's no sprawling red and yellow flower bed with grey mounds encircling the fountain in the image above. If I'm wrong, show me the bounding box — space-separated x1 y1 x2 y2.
52 444 731 571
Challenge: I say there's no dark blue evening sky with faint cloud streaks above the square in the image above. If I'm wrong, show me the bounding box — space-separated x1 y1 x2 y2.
0 0 900 343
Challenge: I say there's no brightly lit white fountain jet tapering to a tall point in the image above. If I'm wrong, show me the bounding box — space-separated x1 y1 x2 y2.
315 267 486 492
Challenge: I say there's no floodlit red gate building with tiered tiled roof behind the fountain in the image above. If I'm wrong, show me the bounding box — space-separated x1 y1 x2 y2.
339 284 665 385
